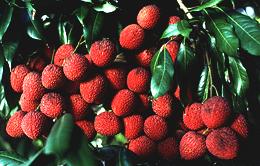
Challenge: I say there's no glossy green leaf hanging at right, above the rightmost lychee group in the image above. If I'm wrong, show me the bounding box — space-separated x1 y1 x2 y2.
229 57 249 96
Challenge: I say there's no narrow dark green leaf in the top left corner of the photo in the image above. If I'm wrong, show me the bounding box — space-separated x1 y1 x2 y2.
0 0 15 42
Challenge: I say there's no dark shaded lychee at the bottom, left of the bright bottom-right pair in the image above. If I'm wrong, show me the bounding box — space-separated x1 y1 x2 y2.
157 137 179 161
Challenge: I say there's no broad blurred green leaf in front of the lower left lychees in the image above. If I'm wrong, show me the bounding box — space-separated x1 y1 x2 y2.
44 114 74 157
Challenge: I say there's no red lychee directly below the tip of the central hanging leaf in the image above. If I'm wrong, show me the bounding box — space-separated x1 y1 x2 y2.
152 94 174 118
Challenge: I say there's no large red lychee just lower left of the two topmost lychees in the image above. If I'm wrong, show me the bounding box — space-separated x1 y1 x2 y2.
89 39 116 67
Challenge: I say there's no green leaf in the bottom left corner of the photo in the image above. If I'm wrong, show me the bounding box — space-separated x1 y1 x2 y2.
0 151 25 166
